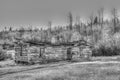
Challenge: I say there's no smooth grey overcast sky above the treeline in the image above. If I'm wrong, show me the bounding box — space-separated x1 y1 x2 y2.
0 0 120 28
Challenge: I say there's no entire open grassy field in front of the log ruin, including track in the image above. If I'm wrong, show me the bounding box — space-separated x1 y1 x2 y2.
0 56 120 80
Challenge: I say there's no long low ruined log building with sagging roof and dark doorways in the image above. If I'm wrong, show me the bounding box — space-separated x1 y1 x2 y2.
15 40 92 64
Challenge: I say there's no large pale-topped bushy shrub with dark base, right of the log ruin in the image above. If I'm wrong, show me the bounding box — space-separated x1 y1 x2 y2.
92 33 120 56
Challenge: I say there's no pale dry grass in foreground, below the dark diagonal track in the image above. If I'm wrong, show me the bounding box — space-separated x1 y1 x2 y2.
0 57 120 80
